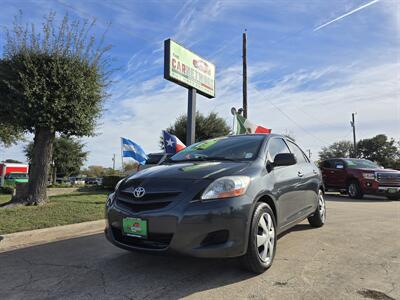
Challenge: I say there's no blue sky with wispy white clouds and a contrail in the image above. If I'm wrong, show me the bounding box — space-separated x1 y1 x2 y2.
0 0 400 166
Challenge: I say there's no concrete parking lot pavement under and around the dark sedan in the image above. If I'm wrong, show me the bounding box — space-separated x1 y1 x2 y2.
0 195 400 299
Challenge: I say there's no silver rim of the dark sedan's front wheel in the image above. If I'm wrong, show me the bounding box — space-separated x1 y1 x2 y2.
257 213 275 264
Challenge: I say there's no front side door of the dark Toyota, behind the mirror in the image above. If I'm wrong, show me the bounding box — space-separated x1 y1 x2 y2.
265 137 304 228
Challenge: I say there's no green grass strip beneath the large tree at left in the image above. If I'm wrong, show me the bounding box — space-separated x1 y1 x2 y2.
0 191 108 234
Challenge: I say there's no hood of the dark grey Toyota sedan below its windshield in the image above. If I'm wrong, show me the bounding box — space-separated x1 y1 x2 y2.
126 162 249 182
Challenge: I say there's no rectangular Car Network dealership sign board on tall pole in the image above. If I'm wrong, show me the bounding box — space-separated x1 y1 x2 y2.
164 39 215 98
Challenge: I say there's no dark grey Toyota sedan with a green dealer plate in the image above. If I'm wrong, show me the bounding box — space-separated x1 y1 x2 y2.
105 134 326 273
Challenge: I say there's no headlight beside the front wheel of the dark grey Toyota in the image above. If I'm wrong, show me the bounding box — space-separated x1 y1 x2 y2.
201 176 250 200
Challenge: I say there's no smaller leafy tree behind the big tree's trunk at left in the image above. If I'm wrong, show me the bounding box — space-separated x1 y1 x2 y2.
25 135 88 177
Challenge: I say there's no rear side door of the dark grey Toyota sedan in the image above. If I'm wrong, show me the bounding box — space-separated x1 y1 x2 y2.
287 141 320 216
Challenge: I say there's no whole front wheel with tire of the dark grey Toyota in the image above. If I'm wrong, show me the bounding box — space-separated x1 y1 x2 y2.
242 202 277 274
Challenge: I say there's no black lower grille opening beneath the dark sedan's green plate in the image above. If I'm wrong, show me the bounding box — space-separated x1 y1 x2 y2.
111 226 173 250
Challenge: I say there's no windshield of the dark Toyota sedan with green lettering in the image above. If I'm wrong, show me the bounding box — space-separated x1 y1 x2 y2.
169 135 264 162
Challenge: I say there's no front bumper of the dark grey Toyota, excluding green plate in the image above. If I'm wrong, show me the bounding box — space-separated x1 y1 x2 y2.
105 195 252 257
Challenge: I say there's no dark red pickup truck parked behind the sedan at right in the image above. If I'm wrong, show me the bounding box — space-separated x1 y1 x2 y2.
320 158 400 200
